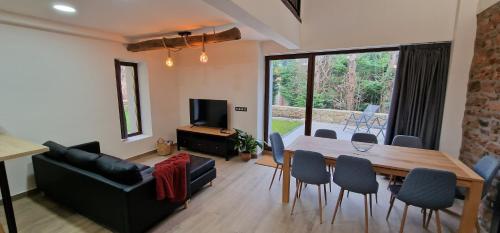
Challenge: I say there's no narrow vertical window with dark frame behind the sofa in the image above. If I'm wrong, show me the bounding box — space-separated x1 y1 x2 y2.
115 59 142 139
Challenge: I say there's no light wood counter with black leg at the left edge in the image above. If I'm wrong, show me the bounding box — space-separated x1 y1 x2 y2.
0 134 49 233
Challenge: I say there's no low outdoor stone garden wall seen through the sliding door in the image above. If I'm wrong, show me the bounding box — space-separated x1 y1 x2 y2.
272 105 387 124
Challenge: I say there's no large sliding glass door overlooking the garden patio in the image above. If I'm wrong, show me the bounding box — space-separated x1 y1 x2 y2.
264 48 399 145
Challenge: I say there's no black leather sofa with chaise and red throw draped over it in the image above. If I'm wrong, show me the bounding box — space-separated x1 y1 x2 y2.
32 142 216 233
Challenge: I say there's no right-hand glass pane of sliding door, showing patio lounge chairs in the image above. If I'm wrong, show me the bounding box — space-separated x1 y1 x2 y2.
311 51 399 144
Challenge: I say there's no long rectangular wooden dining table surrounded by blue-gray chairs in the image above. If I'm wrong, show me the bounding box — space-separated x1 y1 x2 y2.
282 136 484 233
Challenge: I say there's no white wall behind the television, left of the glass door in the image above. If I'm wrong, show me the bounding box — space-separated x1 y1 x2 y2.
175 41 263 136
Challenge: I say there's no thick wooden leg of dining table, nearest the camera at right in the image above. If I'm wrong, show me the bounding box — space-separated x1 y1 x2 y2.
458 182 483 233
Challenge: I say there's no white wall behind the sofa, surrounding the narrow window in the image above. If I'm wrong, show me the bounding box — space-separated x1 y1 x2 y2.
0 24 179 194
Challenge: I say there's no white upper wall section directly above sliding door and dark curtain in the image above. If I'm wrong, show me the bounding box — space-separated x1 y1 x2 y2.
301 0 457 50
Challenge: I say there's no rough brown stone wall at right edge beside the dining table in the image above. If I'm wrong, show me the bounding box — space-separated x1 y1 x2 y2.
458 3 500 231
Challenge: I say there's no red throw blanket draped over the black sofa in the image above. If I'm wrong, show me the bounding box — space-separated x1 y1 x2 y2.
153 153 190 202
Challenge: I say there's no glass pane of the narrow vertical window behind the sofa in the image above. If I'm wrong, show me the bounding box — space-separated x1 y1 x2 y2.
120 65 139 135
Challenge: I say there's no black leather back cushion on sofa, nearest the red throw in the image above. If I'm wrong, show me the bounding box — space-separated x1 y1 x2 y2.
96 155 142 184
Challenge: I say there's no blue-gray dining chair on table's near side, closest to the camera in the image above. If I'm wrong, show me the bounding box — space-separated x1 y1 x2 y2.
396 168 457 233
